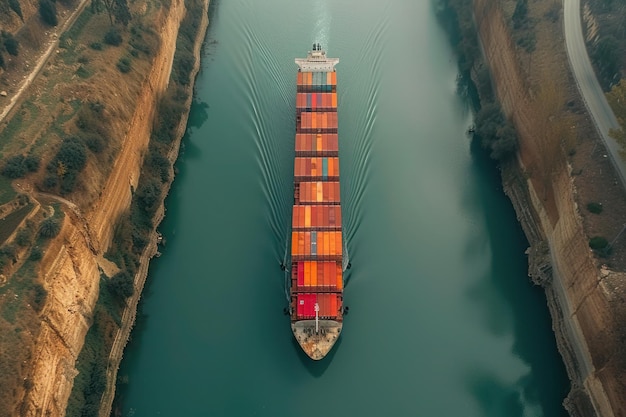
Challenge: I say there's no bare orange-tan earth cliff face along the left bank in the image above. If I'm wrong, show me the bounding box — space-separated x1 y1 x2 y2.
22 0 190 416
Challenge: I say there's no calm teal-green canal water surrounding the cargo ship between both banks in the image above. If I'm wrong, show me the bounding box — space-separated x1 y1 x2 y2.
118 0 568 417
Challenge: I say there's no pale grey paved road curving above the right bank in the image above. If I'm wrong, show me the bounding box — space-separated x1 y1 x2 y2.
563 0 626 188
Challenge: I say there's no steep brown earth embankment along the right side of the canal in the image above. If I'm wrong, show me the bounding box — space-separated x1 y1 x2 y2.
474 0 626 417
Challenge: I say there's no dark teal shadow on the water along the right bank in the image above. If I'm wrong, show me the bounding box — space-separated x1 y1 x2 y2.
466 136 569 416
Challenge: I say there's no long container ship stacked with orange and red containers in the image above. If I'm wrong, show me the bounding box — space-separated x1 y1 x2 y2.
289 44 344 360
